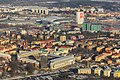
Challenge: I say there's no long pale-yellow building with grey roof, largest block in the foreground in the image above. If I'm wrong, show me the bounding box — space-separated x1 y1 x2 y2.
49 55 75 70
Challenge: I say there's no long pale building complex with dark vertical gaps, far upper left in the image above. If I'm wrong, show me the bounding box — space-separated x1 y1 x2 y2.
0 6 49 15
